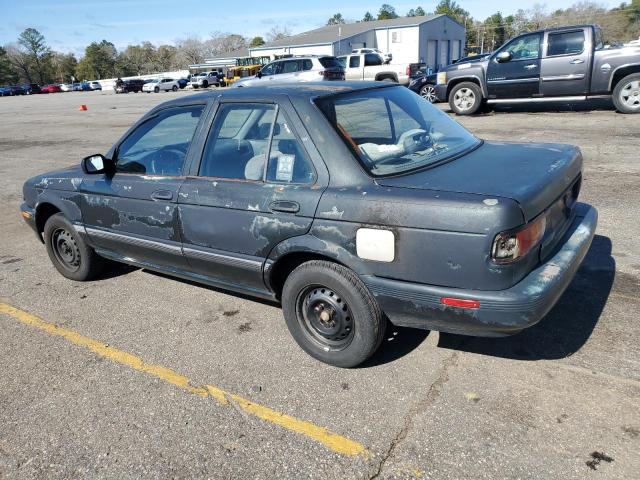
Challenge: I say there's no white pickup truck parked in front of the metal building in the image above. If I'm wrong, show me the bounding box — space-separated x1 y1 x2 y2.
338 53 409 85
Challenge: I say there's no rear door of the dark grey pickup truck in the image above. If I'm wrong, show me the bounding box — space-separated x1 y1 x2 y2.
542 28 593 97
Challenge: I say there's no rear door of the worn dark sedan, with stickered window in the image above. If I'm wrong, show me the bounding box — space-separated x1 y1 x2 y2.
178 96 328 294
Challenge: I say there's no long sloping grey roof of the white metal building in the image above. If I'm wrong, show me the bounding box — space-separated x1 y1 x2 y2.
251 14 444 51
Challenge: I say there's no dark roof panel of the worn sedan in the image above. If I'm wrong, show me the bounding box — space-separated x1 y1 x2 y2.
154 81 404 110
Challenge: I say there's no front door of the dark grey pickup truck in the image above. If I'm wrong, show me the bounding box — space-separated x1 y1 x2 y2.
487 33 542 99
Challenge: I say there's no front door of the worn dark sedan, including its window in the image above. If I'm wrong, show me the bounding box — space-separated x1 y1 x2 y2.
80 104 205 268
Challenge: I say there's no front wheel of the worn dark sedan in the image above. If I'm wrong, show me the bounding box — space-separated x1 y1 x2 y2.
44 213 105 282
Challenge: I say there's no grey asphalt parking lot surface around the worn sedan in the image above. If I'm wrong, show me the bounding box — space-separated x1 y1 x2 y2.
0 92 640 479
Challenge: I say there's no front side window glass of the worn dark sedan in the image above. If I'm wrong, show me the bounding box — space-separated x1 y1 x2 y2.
116 105 204 176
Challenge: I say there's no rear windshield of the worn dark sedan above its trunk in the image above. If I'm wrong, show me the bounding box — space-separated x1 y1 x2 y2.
316 87 480 176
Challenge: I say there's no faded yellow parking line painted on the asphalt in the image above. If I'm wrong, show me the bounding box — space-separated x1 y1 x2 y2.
0 303 369 456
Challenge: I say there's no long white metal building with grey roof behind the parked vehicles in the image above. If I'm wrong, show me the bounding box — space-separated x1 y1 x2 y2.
249 15 465 71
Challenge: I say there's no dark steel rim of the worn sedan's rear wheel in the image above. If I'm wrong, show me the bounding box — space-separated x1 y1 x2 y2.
297 285 353 350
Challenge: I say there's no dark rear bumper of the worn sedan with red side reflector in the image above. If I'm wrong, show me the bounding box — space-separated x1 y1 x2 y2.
362 204 598 337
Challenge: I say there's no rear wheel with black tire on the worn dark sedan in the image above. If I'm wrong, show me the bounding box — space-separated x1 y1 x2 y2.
282 260 387 368
